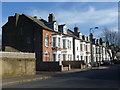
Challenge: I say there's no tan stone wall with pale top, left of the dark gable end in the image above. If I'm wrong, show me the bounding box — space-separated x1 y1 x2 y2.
0 52 36 78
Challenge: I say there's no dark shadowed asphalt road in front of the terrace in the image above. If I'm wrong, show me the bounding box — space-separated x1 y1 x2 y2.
3 66 120 88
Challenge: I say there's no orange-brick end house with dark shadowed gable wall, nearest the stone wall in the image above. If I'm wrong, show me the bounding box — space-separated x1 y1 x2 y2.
2 13 61 70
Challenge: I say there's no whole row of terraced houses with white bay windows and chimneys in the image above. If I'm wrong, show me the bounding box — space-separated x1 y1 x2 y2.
2 13 112 70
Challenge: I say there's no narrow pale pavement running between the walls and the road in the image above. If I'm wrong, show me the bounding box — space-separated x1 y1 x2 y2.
2 66 113 86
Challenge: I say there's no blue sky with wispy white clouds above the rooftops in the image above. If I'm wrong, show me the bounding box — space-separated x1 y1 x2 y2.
2 2 118 38
